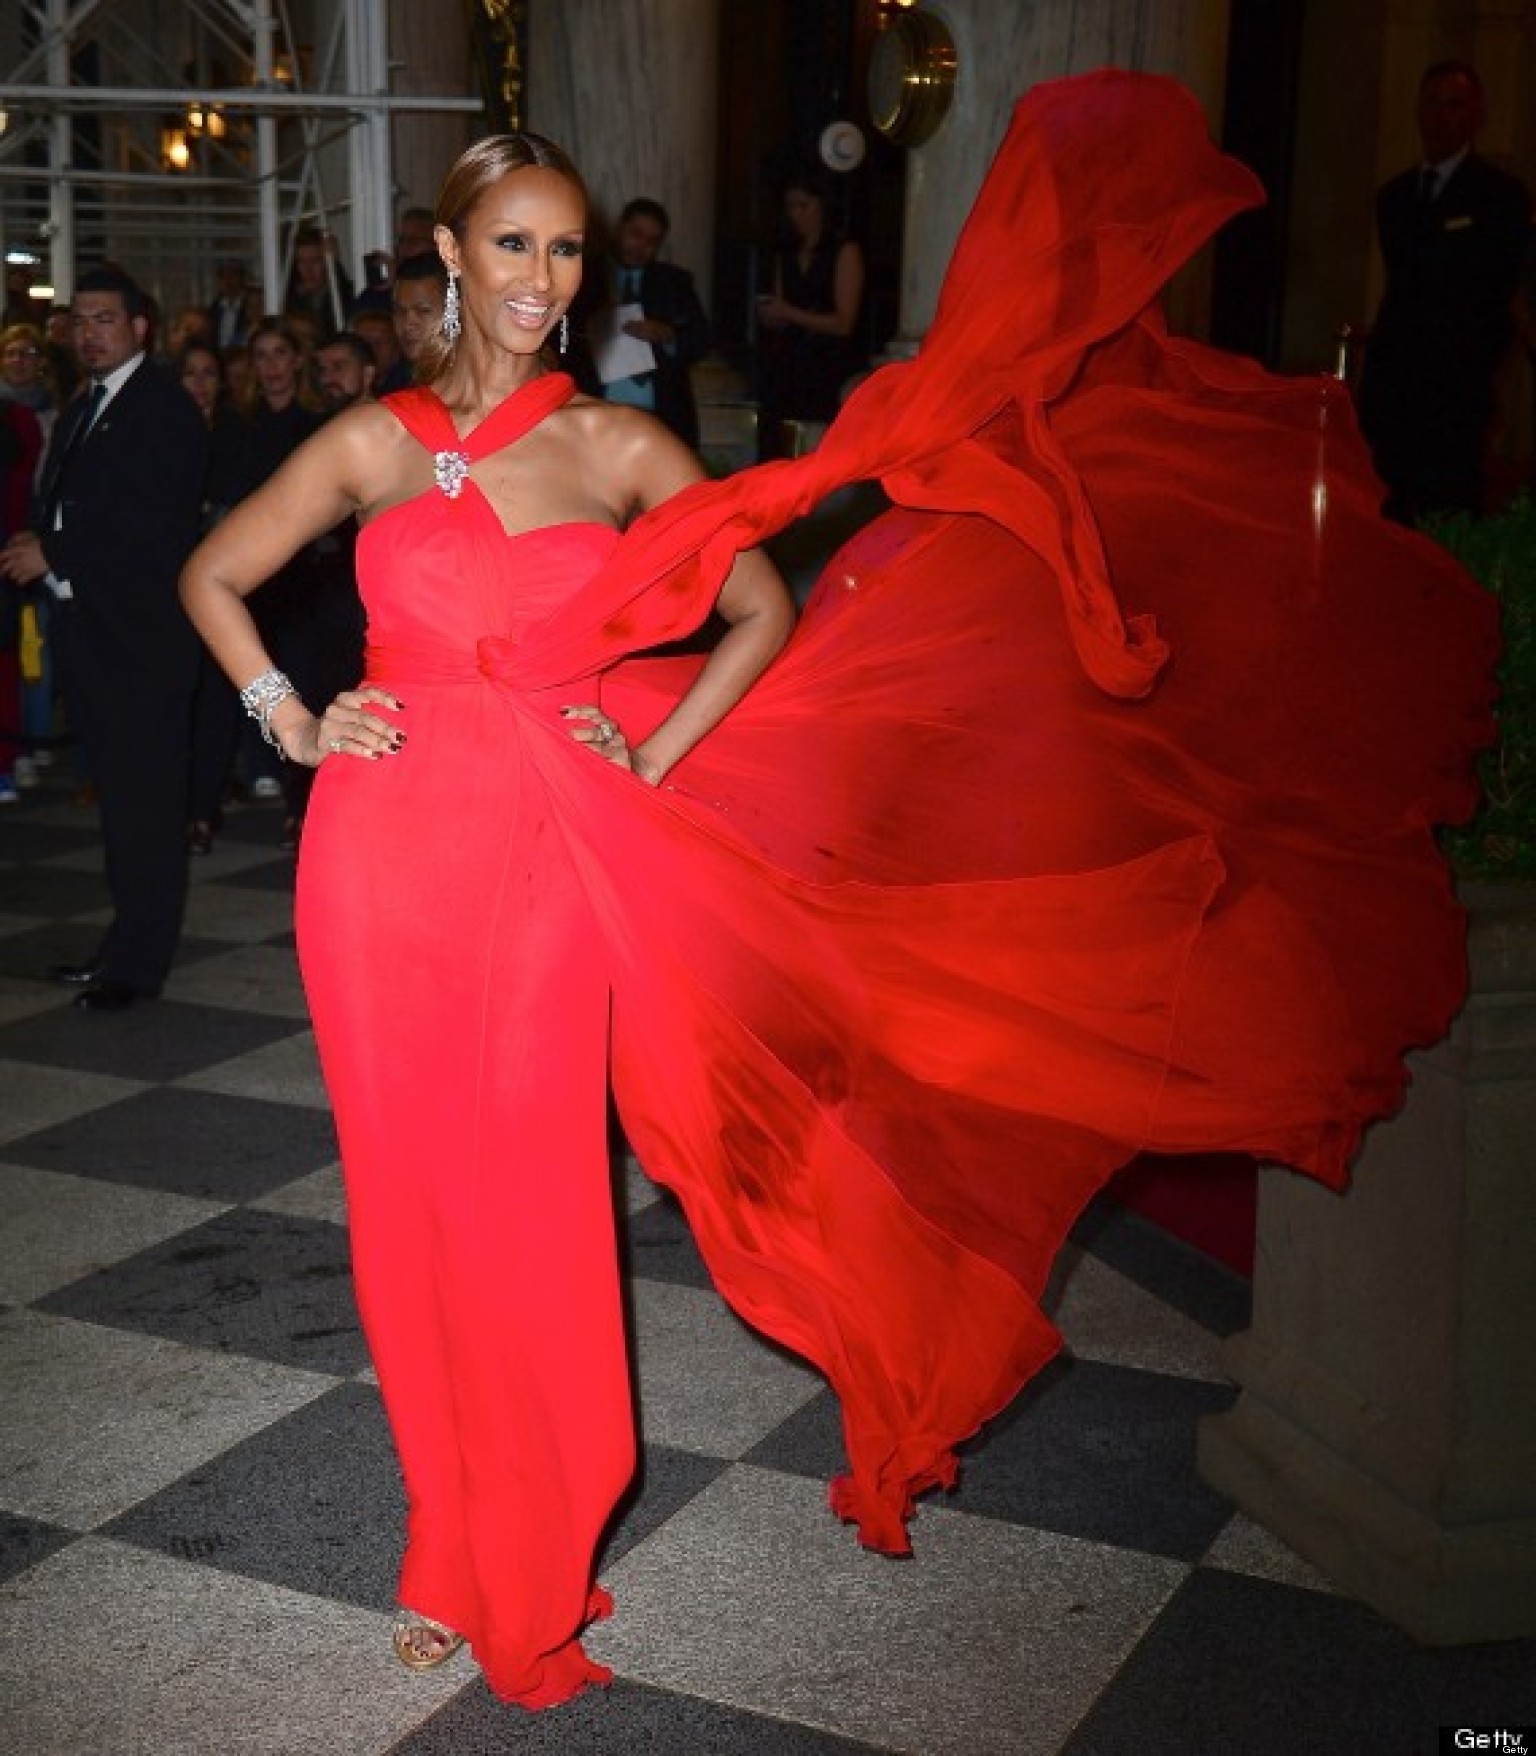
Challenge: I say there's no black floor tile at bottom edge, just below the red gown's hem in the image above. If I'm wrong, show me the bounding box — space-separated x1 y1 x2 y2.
390 1659 876 1756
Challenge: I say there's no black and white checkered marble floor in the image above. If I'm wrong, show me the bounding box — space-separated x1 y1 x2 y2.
0 771 1536 1756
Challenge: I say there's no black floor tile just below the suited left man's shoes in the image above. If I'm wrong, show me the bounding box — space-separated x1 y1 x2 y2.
0 997 305 1080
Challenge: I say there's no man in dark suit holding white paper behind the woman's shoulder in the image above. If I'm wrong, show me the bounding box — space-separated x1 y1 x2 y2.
597 197 709 448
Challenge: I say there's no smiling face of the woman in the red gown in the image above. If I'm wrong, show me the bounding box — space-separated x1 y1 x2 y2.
437 165 586 355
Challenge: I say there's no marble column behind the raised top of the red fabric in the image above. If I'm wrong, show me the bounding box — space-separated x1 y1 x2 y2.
894 0 1227 351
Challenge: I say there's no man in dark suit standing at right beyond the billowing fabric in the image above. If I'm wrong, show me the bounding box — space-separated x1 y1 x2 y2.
1360 61 1531 523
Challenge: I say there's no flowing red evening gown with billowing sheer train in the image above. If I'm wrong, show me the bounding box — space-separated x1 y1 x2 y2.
300 74 1494 1705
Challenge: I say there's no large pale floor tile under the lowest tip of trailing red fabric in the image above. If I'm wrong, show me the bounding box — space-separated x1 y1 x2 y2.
590 1465 1187 1756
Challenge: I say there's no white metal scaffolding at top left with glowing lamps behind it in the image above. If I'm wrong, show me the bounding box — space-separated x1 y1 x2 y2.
0 0 481 311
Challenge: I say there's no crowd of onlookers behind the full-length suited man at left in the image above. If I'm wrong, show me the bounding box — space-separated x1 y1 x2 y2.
0 209 446 832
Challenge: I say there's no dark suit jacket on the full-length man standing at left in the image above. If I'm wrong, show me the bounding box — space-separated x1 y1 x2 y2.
37 360 209 690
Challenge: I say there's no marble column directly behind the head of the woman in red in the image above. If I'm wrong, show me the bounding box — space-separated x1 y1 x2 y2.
528 0 720 306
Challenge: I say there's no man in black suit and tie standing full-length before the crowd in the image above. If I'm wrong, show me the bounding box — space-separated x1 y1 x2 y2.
0 259 207 1011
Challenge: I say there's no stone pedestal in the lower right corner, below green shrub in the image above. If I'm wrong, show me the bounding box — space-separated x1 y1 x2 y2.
1199 887 1536 1644
